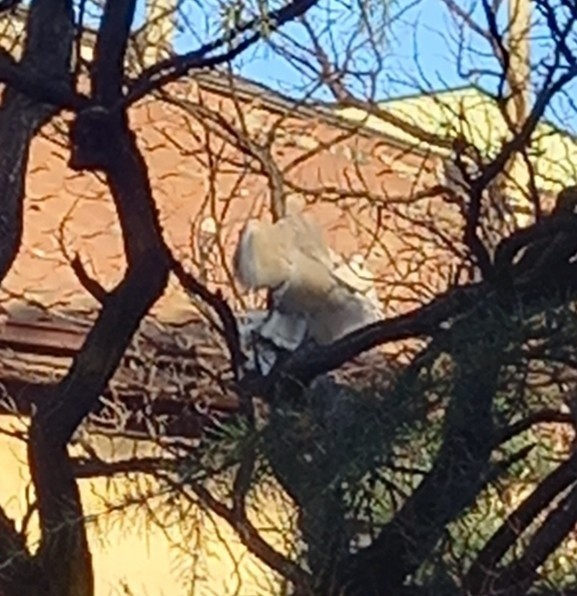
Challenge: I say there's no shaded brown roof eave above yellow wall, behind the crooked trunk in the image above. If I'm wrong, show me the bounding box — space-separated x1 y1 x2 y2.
0 317 237 439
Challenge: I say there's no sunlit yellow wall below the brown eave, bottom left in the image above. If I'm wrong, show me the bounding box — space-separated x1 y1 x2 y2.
0 417 291 596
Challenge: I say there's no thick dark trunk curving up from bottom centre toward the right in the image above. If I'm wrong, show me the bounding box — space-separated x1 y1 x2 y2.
340 305 507 596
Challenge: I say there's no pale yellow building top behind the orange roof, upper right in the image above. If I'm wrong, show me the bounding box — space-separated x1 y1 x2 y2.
336 86 577 193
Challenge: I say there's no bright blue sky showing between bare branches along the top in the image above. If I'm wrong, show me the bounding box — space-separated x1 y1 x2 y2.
173 0 577 133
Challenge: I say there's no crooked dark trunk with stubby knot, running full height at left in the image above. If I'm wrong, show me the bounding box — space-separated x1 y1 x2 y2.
28 8 170 596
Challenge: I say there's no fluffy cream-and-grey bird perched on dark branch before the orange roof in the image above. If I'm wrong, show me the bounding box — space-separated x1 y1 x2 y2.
233 198 382 350
